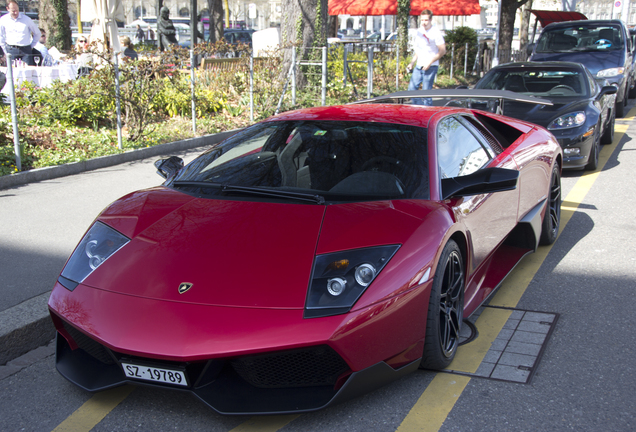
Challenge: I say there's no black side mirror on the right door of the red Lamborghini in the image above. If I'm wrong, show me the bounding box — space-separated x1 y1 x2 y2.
442 168 519 199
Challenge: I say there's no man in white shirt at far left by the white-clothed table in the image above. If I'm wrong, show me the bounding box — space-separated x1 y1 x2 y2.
0 0 41 66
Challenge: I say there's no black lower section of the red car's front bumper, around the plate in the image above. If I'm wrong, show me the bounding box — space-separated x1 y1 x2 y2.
56 330 420 415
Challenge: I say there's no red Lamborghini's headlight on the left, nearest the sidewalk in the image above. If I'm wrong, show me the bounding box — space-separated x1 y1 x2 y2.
60 222 130 291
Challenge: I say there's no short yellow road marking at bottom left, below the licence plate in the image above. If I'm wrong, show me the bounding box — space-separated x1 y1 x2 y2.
53 385 135 432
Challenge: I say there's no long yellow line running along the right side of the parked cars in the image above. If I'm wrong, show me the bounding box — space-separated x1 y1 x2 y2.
398 108 636 432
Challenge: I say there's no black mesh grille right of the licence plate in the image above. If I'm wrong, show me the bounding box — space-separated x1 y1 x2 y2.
231 346 349 388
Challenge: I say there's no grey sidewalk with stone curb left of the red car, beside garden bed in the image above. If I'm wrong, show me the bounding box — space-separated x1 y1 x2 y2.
0 130 237 365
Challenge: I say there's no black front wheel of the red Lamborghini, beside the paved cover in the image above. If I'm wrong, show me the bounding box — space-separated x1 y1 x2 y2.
420 240 465 370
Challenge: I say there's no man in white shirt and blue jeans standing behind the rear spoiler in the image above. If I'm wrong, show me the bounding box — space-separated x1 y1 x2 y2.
406 9 446 105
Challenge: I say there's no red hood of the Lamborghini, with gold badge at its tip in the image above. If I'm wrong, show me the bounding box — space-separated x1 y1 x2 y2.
83 188 426 309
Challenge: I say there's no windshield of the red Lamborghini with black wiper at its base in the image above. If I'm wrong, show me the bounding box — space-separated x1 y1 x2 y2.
168 121 429 203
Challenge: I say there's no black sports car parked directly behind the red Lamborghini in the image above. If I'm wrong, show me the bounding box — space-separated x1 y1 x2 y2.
475 62 616 170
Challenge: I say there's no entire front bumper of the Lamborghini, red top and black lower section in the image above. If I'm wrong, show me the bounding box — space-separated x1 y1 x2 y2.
49 281 431 414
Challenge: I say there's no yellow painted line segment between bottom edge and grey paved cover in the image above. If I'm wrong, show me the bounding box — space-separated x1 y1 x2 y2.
397 373 470 432
